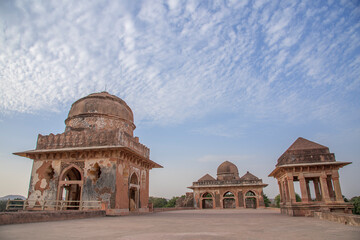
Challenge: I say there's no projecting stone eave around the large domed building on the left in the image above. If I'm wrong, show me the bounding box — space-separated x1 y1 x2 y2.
13 145 163 168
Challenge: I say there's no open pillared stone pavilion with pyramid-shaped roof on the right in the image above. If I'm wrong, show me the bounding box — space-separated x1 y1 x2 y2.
269 138 352 216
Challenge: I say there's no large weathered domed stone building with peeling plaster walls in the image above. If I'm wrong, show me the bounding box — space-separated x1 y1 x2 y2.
14 92 162 214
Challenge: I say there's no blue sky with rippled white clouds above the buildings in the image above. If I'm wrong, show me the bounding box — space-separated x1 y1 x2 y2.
0 1 360 198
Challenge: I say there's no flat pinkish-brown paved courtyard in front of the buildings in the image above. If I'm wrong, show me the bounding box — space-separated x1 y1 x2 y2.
0 209 360 240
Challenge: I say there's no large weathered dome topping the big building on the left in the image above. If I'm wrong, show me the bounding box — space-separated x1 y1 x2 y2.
65 92 135 135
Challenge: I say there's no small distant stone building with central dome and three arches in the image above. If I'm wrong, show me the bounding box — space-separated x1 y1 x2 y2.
189 161 267 209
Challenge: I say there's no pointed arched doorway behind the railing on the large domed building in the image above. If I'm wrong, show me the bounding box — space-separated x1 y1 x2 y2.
58 166 83 210
